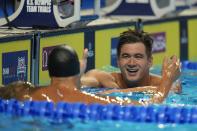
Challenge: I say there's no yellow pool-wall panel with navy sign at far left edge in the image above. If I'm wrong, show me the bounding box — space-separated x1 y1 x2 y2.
0 31 34 85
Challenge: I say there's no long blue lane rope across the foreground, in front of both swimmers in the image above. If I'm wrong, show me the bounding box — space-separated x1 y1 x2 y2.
0 99 197 124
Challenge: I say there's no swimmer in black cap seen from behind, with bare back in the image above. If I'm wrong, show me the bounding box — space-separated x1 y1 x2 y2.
24 45 140 105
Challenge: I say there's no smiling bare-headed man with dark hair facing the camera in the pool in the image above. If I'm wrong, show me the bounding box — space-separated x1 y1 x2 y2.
81 29 181 103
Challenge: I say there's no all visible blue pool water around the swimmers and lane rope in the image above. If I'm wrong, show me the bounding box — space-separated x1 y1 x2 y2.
0 67 197 131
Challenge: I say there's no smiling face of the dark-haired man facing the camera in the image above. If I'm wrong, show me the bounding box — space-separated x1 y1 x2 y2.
117 42 152 84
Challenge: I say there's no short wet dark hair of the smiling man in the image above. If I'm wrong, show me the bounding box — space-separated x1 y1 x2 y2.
117 29 153 57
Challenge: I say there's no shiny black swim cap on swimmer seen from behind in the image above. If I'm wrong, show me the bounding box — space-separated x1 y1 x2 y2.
48 45 80 77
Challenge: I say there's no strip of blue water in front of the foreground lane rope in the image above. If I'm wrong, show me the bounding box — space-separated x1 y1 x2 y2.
0 115 197 131
